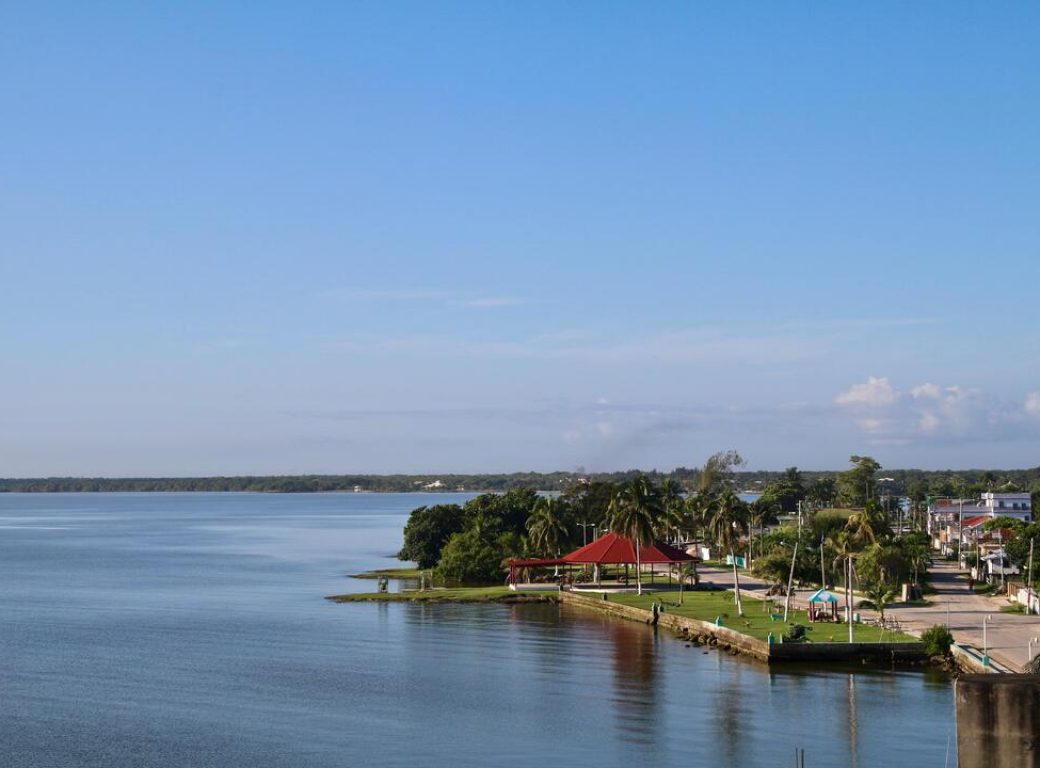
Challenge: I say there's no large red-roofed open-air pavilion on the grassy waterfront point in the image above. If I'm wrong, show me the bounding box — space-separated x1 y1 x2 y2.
508 533 700 589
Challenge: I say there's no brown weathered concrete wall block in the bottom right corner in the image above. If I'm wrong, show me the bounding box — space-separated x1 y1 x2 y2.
955 674 1040 768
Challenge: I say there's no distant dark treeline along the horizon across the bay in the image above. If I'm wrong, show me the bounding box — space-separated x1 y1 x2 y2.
0 467 1040 495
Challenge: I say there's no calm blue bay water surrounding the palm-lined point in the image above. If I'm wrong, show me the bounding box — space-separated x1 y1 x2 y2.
0 493 955 768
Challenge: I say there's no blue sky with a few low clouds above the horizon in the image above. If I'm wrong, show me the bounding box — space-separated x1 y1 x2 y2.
0 0 1040 477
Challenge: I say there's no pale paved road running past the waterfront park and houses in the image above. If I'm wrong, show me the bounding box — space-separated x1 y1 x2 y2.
700 563 1040 671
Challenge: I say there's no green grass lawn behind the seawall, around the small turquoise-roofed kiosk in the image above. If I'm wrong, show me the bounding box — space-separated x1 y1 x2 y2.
610 590 915 643
